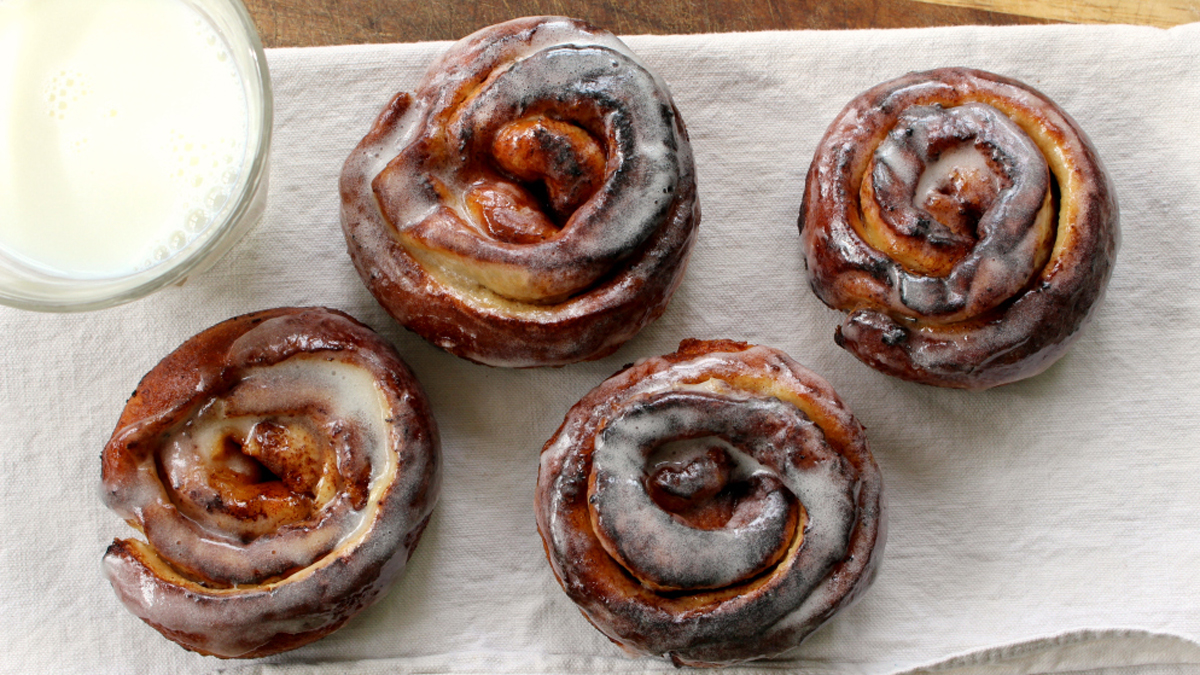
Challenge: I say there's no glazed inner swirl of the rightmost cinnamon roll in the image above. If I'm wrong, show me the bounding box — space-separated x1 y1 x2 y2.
857 102 1056 323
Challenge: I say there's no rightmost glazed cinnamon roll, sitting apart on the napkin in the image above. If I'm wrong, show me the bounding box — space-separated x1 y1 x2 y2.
799 68 1118 389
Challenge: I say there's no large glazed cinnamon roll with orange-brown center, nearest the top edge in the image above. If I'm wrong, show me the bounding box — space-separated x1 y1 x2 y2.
341 17 700 368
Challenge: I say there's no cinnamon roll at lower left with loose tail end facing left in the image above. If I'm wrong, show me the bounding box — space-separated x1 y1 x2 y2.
102 309 440 658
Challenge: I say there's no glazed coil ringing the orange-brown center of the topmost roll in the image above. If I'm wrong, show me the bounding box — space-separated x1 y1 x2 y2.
372 44 680 301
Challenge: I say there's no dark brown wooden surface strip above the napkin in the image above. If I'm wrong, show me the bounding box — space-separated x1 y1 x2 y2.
244 0 1045 47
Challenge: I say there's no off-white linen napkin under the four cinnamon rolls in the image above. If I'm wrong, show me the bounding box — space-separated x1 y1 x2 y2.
0 24 1200 674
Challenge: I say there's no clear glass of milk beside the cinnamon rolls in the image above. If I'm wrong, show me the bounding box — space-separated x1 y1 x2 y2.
0 0 272 311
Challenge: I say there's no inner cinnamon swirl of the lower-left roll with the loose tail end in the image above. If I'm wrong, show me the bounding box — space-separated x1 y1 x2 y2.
146 374 370 587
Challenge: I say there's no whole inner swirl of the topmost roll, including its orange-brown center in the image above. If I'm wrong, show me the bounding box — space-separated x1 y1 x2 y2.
370 39 691 306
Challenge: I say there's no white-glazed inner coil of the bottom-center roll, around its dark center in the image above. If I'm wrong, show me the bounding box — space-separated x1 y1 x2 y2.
592 396 853 590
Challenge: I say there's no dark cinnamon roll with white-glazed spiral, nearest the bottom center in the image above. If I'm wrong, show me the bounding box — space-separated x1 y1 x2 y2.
536 340 884 665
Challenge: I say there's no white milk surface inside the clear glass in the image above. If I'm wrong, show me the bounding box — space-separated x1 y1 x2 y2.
0 0 248 279
